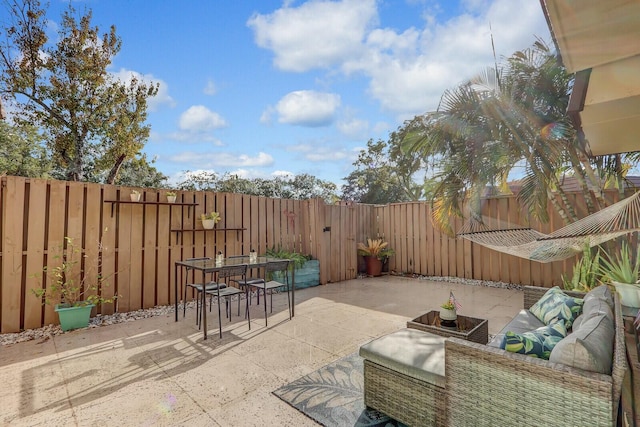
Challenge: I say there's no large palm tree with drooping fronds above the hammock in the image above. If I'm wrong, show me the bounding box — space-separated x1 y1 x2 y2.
404 41 622 231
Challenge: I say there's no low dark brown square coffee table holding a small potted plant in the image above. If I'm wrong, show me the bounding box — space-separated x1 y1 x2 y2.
407 310 489 344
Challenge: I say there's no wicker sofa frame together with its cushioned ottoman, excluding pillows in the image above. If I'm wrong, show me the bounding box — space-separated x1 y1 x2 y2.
360 287 627 427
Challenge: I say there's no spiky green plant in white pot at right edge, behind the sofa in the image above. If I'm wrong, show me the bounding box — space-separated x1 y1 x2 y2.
600 240 640 311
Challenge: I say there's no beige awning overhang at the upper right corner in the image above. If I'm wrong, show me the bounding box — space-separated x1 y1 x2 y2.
540 0 640 155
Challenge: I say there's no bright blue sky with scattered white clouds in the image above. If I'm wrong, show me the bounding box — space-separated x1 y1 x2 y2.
47 0 550 185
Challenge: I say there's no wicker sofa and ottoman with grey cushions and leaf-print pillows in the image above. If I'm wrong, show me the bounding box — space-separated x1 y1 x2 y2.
360 285 627 426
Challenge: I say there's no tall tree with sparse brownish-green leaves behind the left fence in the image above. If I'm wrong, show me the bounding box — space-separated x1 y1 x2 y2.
0 0 158 183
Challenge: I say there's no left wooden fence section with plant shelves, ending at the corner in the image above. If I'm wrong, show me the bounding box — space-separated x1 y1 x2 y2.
0 177 356 333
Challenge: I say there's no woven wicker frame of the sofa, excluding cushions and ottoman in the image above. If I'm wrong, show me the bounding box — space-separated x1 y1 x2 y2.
445 287 627 426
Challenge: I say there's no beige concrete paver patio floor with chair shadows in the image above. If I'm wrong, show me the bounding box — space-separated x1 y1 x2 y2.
0 276 523 426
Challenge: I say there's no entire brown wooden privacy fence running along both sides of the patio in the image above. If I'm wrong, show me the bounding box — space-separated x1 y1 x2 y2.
0 177 624 333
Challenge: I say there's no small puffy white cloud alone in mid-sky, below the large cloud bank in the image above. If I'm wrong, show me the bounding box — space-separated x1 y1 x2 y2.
278 90 340 127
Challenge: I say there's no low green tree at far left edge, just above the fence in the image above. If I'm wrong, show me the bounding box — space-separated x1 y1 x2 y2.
0 120 51 178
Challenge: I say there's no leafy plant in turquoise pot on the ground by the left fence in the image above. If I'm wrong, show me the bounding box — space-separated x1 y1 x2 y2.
31 237 117 331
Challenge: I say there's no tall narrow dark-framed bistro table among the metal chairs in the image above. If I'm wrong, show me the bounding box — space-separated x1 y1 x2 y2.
174 255 296 340
